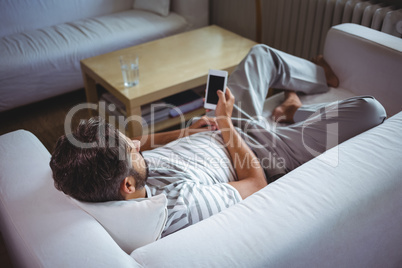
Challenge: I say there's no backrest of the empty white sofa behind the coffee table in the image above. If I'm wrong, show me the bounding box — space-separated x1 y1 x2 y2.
0 0 133 37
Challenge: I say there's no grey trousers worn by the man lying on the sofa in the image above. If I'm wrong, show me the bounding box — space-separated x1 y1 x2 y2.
228 45 386 182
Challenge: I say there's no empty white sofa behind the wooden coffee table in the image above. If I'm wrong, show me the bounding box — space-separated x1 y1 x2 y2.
0 0 209 112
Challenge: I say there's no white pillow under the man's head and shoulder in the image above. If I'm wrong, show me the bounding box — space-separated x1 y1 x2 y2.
71 195 167 254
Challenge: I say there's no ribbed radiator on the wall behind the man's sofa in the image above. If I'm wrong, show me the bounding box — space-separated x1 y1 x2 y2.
257 0 402 59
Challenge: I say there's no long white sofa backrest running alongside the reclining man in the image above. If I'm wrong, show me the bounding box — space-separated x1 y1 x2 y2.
131 112 402 267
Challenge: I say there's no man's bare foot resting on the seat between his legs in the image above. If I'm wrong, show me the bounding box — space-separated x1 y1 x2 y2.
272 91 302 123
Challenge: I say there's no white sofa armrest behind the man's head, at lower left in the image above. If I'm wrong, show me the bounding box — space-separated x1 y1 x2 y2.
0 130 140 268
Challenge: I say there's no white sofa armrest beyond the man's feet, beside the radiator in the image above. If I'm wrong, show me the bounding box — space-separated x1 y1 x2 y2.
324 23 402 116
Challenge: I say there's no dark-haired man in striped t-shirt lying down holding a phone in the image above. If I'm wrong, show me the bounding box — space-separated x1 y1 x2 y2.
50 45 386 236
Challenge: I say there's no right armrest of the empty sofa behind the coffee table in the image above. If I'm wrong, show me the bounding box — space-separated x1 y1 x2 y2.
171 0 209 30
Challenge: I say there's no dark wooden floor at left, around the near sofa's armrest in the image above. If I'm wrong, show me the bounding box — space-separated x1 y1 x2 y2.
0 89 89 268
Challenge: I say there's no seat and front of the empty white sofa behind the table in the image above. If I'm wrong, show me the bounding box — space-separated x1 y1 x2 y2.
0 10 187 111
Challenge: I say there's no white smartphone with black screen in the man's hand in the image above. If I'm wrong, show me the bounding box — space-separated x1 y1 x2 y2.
204 70 228 110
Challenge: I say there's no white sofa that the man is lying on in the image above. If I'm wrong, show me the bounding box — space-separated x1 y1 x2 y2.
0 24 402 268
